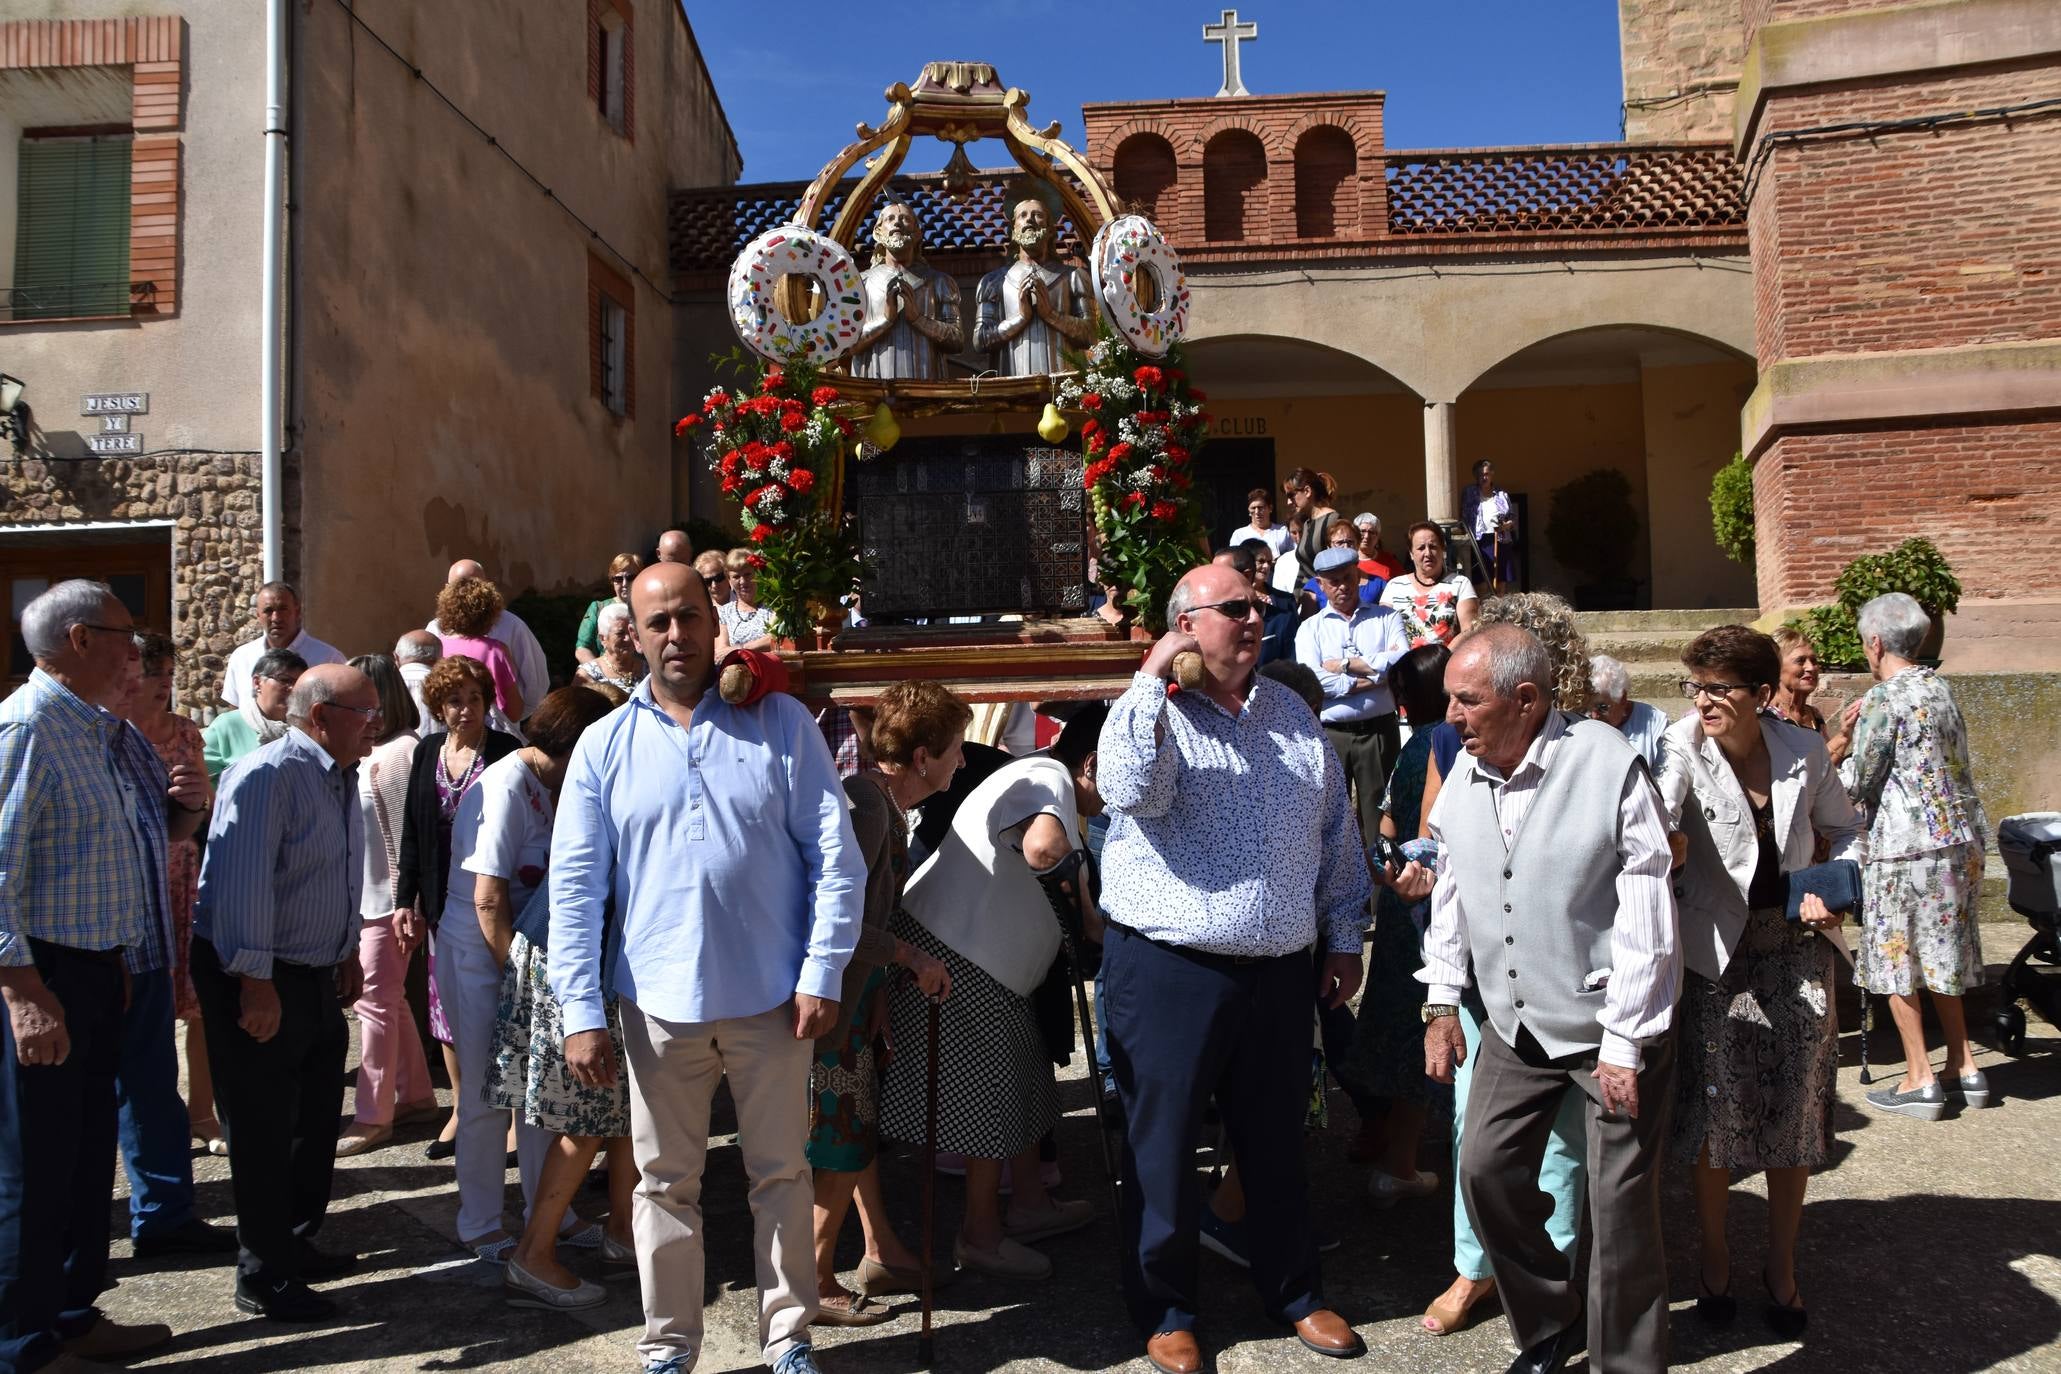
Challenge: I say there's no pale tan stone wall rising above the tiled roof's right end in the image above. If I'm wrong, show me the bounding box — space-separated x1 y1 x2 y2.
1618 0 1756 142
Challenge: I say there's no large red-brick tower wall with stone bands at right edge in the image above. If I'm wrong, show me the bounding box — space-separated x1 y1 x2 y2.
1739 0 2061 606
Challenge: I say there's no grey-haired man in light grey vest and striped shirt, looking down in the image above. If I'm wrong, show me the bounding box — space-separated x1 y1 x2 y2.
1399 624 1682 1374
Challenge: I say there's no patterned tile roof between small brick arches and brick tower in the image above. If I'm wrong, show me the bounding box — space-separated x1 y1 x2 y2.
1387 146 1746 235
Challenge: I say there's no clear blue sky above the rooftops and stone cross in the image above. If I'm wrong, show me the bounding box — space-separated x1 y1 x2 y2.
686 0 1622 181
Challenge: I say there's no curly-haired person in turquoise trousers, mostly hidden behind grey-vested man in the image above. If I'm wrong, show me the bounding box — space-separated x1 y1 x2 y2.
1418 591 1589 1335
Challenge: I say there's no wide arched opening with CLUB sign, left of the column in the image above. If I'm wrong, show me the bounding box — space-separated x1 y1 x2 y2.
1185 334 1424 546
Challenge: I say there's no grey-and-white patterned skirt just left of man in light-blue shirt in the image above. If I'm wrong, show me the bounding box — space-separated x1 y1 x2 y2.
480 935 631 1139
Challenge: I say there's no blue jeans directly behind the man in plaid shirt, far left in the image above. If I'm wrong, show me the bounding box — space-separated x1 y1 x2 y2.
115 968 194 1236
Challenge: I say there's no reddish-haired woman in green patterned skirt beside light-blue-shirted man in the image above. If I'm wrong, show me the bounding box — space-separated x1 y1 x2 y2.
808 682 973 1327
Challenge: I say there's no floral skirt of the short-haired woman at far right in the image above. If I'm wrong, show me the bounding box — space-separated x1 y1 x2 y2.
1853 845 1983 997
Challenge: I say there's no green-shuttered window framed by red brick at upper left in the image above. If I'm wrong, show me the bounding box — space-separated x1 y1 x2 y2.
8 134 130 319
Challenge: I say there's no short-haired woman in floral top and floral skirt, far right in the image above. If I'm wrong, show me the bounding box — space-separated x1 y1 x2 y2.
1828 591 1989 1121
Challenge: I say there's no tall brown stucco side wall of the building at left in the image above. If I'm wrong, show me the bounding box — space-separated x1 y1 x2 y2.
297 0 736 667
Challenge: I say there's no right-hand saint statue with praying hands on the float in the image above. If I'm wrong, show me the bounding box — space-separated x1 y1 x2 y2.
973 190 1094 377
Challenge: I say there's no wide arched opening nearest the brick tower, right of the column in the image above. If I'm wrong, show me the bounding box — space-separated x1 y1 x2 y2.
1457 325 1756 610
